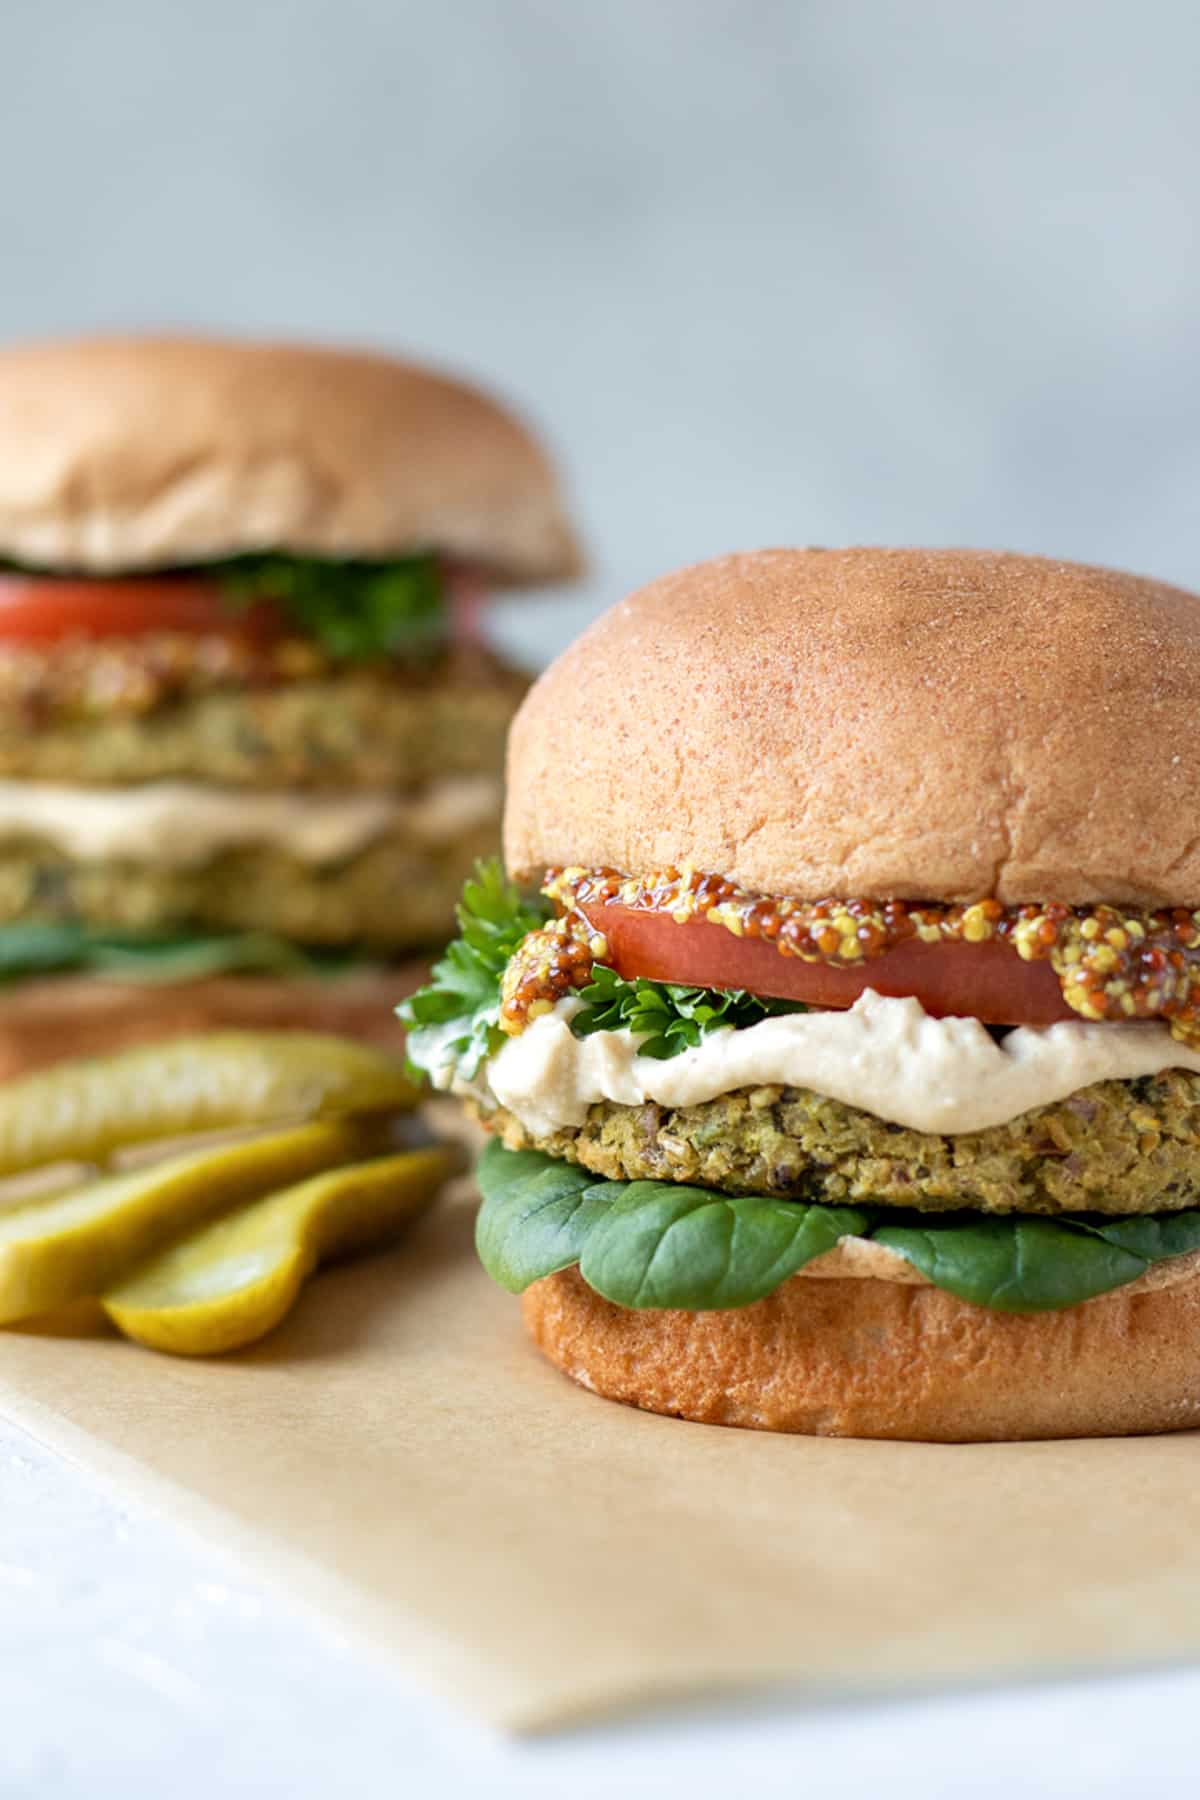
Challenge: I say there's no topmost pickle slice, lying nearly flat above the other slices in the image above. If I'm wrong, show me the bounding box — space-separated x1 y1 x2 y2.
0 1031 417 1177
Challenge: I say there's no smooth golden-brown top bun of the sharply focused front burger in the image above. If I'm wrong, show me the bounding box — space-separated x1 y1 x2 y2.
506 549 1200 907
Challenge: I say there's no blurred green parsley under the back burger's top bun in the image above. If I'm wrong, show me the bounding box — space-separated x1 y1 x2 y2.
203 551 446 662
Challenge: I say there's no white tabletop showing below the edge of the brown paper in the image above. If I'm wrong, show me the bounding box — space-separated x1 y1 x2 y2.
0 1422 1200 1800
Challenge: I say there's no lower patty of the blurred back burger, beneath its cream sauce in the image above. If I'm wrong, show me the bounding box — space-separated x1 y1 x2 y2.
0 819 498 954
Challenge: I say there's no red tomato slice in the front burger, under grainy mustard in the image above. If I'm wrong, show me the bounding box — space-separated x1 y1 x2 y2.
583 902 1079 1026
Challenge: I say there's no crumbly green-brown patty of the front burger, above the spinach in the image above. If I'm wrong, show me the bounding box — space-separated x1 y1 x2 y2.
484 1069 1200 1215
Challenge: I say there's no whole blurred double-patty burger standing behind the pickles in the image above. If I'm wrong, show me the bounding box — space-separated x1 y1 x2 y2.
0 338 579 1075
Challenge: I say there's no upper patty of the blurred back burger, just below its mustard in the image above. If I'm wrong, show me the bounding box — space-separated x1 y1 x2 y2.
0 644 527 788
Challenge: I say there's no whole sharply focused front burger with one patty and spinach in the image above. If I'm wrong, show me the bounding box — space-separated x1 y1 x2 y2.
407 549 1200 1442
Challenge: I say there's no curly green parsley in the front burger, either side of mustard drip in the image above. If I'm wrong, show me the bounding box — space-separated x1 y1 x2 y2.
399 860 804 1080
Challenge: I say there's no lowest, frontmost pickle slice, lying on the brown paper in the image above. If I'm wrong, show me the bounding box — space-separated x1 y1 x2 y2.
103 1148 461 1355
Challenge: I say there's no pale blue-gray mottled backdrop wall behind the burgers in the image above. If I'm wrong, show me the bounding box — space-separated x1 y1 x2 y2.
0 0 1200 653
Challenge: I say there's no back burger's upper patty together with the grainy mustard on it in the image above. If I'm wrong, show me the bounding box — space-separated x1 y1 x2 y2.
0 635 527 788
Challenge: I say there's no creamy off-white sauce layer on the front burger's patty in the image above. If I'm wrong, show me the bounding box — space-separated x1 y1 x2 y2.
444 988 1200 1136
